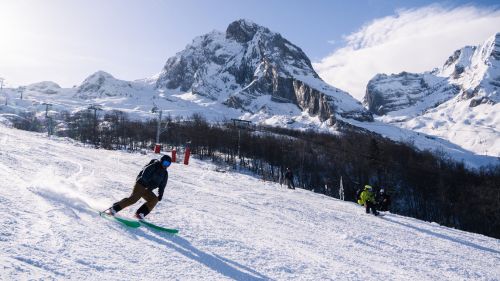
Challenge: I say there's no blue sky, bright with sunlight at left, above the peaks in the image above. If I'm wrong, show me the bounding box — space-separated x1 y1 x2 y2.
0 0 500 98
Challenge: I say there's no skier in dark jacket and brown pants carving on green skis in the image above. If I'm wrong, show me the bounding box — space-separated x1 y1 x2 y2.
106 155 172 219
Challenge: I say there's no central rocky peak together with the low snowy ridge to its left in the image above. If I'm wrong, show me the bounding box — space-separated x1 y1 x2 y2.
3 20 373 128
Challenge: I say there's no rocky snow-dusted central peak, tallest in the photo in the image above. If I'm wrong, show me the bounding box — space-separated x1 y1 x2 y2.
156 20 373 121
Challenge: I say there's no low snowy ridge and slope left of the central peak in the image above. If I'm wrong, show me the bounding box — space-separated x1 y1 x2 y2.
0 71 249 123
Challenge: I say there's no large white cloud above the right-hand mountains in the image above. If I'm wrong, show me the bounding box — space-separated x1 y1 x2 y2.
313 5 500 100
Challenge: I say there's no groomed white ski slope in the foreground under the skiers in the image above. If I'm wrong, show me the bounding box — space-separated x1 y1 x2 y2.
0 127 500 280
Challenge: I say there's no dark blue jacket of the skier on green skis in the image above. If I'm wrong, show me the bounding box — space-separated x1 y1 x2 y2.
136 160 168 200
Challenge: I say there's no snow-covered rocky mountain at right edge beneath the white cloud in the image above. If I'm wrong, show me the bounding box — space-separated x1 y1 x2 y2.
364 33 500 156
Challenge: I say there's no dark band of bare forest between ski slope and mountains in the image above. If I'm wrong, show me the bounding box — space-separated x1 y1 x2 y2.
8 110 500 238
